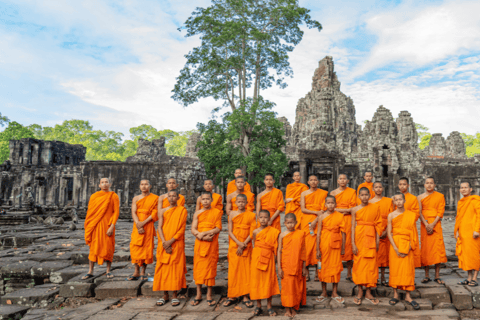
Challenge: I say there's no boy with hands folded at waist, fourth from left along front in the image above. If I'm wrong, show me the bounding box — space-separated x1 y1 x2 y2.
191 191 222 306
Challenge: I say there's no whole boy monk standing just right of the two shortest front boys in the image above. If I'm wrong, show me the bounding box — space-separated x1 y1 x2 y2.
317 195 346 304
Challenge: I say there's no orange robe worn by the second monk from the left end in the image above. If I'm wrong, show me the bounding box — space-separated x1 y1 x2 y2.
130 193 158 266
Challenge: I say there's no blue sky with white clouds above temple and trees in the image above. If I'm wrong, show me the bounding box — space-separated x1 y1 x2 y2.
0 0 480 138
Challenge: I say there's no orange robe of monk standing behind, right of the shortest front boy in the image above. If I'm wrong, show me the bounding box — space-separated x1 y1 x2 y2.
300 189 328 266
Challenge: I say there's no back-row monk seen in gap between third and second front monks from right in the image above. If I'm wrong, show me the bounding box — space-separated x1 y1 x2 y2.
330 173 357 281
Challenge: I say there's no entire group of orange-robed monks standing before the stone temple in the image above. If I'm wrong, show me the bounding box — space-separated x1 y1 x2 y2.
83 169 480 317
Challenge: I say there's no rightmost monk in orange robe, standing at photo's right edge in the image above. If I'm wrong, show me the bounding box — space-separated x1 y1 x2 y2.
454 182 480 287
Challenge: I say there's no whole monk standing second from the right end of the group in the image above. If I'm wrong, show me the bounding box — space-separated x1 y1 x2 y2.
418 177 447 284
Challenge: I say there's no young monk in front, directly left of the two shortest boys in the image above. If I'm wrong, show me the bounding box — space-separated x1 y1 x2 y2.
223 194 256 308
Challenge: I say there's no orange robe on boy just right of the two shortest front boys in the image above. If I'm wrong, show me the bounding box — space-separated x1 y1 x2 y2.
318 211 344 283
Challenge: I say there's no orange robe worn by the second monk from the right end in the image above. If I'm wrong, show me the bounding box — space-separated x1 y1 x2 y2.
420 191 447 266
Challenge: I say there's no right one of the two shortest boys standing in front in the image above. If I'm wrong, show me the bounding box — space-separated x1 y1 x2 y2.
277 212 307 318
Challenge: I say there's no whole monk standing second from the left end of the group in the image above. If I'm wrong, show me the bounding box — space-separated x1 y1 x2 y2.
125 179 158 281
